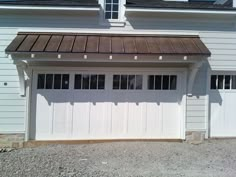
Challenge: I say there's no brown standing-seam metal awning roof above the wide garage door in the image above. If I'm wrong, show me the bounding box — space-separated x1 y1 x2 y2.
6 33 211 56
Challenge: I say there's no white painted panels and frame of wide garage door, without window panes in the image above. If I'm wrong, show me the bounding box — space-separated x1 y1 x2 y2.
31 68 185 140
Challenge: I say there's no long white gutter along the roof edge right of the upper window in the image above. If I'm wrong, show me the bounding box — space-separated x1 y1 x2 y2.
126 7 236 15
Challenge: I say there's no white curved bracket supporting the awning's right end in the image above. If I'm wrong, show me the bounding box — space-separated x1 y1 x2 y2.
187 61 203 97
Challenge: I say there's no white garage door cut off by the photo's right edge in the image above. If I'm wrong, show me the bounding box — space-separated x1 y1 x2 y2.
210 73 236 137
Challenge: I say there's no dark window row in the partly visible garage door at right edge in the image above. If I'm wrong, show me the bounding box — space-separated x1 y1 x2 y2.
211 75 236 90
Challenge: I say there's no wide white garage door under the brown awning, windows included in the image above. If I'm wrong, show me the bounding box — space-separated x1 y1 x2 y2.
31 71 185 140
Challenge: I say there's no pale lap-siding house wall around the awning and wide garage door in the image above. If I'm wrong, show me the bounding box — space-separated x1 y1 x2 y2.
0 11 236 140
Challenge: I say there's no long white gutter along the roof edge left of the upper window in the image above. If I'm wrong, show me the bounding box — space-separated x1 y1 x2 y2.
0 5 100 11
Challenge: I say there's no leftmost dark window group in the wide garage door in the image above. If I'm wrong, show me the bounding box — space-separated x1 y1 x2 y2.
37 74 70 89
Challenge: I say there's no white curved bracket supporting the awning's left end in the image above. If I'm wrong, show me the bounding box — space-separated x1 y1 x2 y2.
14 62 27 96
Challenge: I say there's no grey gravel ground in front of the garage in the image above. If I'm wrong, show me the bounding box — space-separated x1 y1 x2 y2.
0 140 236 177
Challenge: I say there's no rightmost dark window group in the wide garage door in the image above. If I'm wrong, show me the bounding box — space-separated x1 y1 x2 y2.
148 75 177 90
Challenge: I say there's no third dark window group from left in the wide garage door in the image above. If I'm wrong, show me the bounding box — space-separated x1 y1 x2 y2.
113 75 143 90
